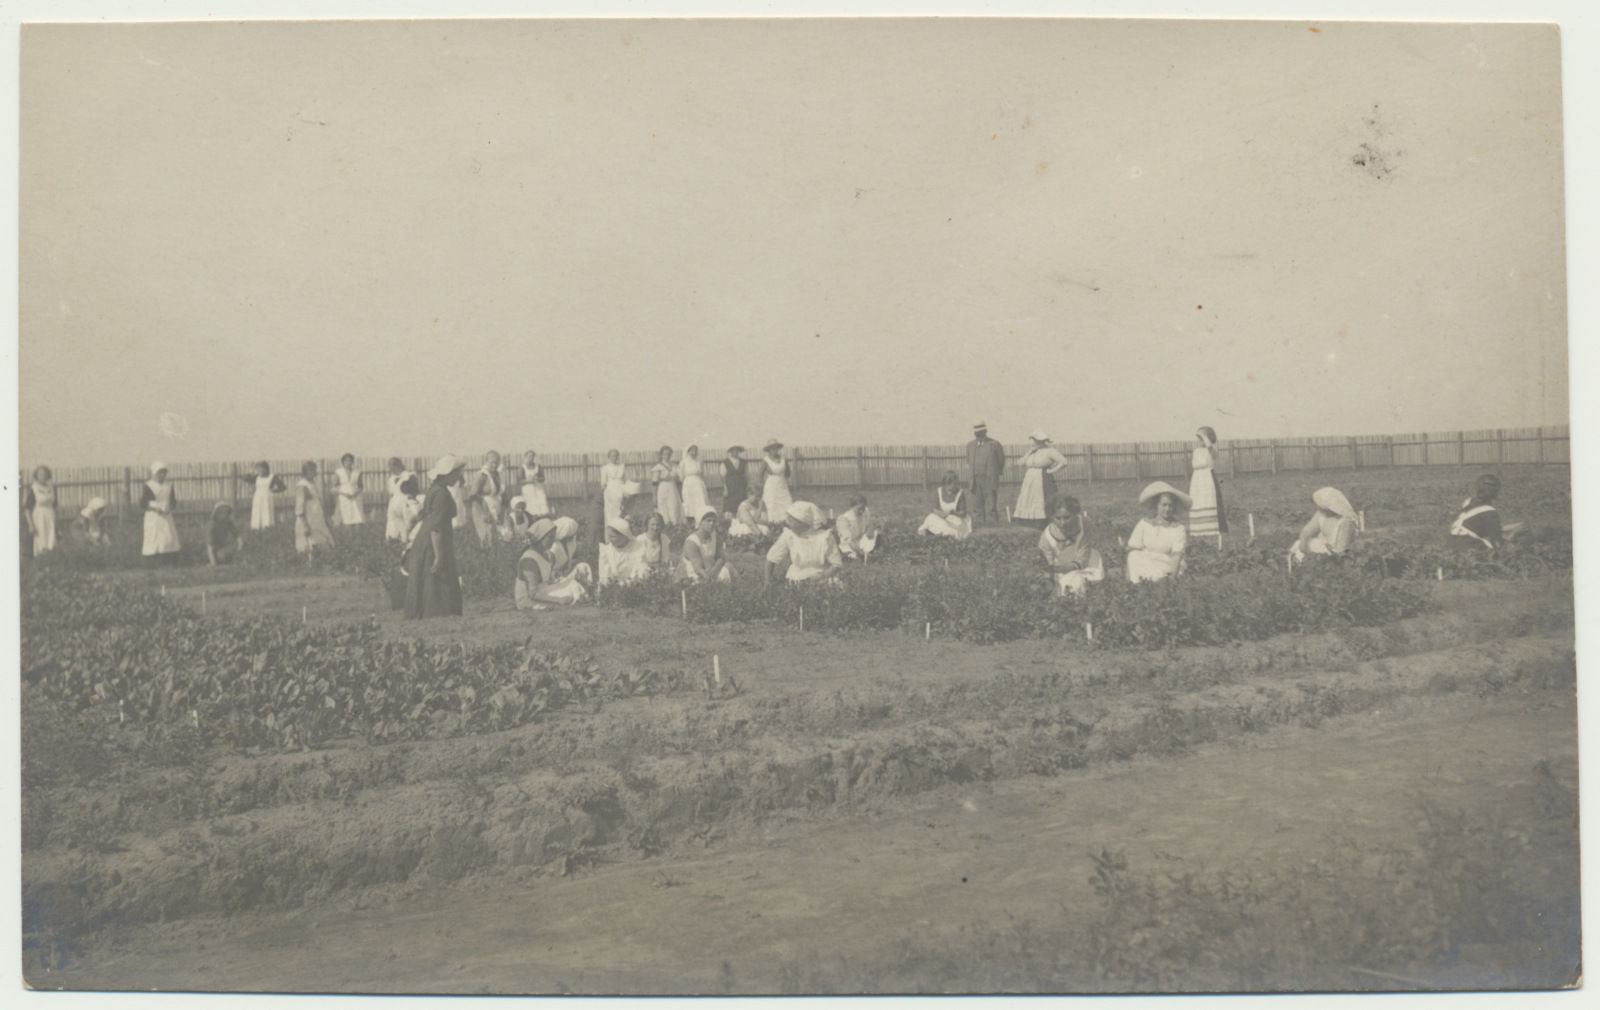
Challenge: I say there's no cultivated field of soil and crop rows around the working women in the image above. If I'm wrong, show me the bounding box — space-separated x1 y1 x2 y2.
24 467 1578 992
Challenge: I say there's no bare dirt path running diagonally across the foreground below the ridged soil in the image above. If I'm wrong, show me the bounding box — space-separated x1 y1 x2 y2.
50 691 1578 992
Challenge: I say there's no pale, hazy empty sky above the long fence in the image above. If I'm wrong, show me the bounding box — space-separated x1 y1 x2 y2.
19 21 1568 464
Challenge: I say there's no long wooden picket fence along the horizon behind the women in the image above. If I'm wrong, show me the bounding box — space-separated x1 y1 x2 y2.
28 426 1571 522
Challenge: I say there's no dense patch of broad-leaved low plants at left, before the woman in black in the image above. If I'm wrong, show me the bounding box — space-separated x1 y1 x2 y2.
22 571 688 749
